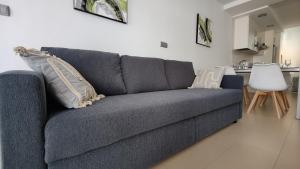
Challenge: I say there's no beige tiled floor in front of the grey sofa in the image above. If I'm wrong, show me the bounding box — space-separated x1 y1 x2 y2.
153 94 300 169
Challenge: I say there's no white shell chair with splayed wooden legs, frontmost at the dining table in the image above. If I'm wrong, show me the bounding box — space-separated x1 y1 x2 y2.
247 64 288 119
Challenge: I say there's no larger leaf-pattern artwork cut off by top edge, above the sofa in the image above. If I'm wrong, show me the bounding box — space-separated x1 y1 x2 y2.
73 0 128 23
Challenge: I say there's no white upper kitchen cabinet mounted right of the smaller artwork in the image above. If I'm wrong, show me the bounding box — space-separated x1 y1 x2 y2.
233 15 258 53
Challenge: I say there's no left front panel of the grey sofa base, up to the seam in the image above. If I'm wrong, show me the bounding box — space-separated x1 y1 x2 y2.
48 119 196 169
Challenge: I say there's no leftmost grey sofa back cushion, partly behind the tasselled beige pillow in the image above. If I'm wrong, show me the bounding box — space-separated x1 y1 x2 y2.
42 47 126 96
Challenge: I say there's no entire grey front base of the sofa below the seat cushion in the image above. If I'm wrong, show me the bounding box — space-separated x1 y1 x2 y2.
48 104 241 169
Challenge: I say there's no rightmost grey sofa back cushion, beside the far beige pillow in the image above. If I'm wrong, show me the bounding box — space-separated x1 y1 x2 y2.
165 60 195 90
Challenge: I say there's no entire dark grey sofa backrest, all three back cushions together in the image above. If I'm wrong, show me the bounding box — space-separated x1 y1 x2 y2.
41 47 195 96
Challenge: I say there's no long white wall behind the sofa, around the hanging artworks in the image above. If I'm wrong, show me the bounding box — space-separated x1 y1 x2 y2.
0 0 232 72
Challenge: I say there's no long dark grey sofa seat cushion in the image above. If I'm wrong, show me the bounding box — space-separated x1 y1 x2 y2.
45 89 242 163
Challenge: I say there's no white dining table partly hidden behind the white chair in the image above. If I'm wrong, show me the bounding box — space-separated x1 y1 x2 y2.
234 67 300 120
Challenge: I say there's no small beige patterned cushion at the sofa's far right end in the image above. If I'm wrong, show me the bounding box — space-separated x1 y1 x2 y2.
190 67 225 89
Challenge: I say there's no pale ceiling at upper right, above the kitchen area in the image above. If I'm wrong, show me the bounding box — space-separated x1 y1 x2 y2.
218 0 300 29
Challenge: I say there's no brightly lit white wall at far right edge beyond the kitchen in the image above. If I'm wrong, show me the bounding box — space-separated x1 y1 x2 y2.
281 27 300 66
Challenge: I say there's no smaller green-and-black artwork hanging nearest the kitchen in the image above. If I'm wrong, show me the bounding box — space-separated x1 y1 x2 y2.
196 14 212 47
